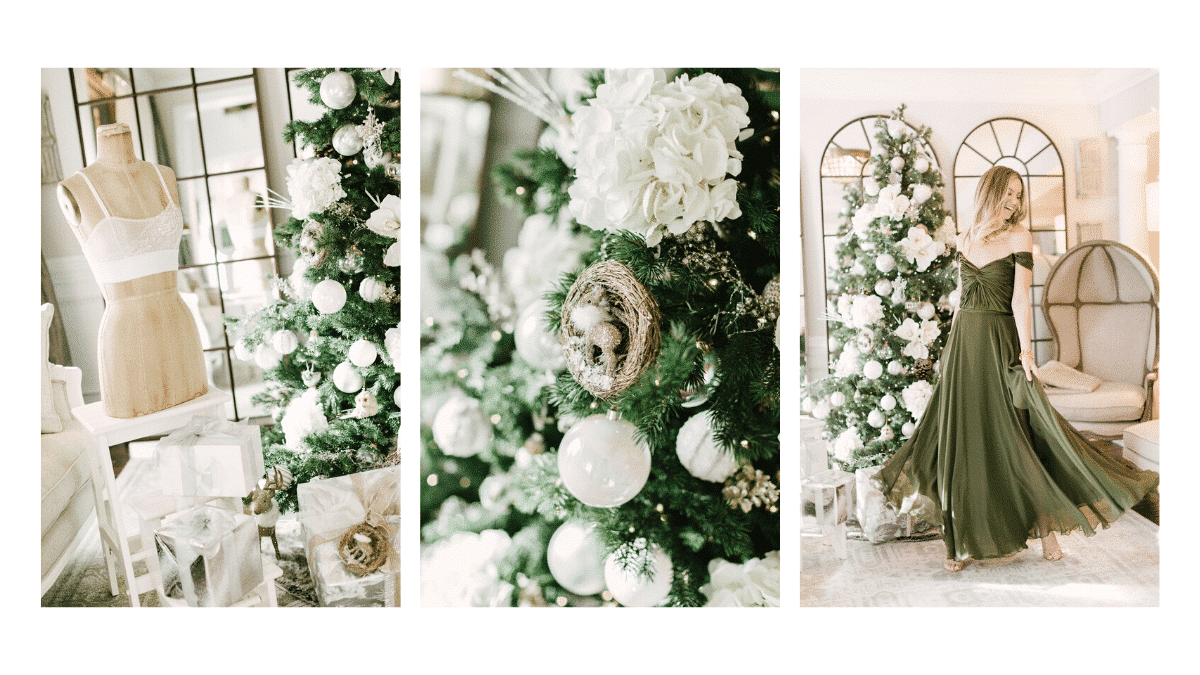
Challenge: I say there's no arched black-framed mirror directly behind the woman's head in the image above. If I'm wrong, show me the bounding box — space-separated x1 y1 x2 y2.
954 118 1068 364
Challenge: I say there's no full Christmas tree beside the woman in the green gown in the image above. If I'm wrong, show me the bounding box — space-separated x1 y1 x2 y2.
803 106 956 471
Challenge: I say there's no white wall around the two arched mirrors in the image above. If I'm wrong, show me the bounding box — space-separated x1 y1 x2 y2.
793 68 1157 380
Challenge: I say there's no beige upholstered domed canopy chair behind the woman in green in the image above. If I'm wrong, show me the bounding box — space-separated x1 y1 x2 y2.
1042 240 1158 440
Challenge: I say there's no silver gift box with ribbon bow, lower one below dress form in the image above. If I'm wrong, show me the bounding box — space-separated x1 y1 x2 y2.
155 506 263 607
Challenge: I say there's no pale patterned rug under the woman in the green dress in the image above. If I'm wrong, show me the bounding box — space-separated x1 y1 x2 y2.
800 512 1159 607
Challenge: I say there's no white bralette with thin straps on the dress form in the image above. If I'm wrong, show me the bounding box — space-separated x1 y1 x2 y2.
79 165 184 283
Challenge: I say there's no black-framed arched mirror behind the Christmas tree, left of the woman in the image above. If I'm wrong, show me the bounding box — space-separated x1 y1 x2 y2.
821 115 940 363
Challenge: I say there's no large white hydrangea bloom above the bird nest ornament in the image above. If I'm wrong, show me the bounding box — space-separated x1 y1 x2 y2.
568 70 751 246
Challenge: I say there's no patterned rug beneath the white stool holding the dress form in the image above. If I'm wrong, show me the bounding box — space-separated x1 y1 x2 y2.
42 456 317 607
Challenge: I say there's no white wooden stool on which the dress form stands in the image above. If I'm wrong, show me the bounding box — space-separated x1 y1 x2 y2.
71 387 233 607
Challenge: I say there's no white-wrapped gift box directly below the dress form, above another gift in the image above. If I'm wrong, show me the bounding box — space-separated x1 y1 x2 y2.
155 417 265 497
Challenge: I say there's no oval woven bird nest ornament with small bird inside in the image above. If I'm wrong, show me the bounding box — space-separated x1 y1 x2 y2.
559 261 661 400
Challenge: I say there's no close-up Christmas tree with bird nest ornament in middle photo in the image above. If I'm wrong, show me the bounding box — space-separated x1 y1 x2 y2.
421 70 780 605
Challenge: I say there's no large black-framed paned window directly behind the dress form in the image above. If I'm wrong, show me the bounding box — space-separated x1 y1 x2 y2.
70 68 277 419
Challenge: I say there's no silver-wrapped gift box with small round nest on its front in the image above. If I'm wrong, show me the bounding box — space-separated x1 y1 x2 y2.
296 466 400 607
